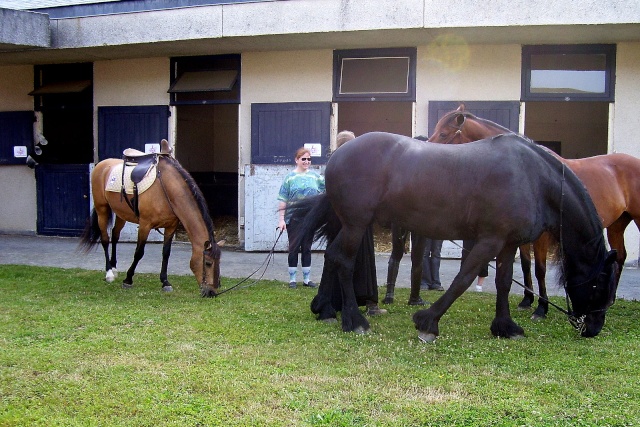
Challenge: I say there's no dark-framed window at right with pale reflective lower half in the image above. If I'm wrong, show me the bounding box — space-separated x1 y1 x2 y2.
522 44 616 102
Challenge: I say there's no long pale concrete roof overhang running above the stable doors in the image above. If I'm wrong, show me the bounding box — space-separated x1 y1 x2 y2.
0 0 640 65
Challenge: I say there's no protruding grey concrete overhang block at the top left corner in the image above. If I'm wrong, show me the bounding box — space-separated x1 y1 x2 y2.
0 8 51 52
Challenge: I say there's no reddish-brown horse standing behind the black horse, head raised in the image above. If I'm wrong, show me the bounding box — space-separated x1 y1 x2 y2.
429 105 640 318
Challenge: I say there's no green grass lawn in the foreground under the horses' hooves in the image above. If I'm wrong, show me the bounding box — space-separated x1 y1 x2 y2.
0 266 640 426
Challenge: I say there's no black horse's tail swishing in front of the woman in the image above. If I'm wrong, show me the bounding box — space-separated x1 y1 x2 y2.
287 193 342 247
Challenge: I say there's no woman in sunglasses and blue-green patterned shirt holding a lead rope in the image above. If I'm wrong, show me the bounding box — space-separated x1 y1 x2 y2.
278 147 324 289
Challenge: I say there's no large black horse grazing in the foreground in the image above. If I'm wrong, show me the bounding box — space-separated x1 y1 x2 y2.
300 132 617 341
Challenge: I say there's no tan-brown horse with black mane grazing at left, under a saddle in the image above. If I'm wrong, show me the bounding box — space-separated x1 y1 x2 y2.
80 145 222 297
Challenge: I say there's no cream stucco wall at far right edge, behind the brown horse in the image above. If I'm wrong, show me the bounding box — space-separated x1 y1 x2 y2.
611 43 640 265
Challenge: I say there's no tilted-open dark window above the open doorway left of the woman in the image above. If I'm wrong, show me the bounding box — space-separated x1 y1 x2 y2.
167 55 240 105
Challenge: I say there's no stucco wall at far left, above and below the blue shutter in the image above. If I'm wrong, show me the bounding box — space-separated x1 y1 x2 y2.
0 65 38 234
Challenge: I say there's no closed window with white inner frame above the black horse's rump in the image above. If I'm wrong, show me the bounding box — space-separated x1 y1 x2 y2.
333 48 416 102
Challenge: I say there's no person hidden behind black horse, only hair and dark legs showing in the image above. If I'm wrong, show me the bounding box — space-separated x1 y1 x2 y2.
320 130 387 316
